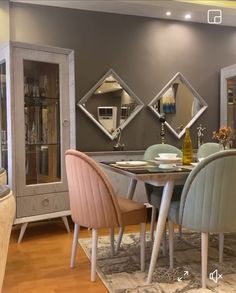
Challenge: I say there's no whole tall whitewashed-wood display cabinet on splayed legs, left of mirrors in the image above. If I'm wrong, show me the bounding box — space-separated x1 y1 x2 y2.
0 42 75 242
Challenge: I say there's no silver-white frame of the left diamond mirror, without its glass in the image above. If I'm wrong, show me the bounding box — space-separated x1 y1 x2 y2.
77 69 144 140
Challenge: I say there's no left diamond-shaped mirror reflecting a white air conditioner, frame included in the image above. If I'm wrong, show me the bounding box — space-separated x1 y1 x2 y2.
77 69 144 139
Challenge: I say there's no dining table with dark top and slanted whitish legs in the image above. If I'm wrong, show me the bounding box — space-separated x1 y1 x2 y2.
100 161 193 284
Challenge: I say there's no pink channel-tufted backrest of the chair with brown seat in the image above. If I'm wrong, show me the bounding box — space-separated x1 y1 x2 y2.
65 150 122 228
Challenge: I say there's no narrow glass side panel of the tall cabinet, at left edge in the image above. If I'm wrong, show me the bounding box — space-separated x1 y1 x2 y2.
0 60 8 170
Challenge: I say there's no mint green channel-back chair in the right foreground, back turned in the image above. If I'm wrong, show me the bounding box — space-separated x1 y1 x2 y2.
169 150 236 288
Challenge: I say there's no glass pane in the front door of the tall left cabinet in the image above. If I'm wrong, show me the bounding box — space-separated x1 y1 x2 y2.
23 59 61 185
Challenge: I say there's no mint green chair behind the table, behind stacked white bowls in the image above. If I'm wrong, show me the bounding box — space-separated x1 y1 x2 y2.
144 144 183 239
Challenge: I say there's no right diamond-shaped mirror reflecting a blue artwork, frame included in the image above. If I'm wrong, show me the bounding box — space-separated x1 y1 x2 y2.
148 72 207 138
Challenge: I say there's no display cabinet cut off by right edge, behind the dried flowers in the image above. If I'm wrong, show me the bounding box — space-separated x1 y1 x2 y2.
220 64 236 148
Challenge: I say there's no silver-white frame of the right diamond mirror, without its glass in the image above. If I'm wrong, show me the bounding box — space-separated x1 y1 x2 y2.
148 72 208 139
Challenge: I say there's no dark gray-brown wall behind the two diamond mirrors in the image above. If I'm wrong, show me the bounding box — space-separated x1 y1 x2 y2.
10 3 236 151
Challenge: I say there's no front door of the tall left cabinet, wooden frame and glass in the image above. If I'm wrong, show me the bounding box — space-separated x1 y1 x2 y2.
14 48 70 196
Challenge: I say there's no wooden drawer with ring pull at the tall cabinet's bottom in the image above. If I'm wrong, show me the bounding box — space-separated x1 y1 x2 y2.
16 192 70 218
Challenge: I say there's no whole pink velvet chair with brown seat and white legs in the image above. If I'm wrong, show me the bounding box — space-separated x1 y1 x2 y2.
65 150 147 281
